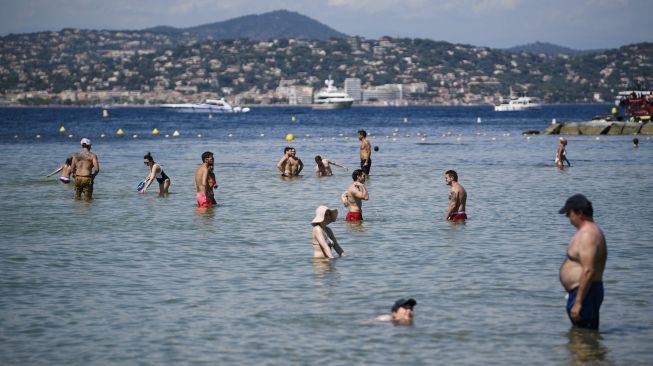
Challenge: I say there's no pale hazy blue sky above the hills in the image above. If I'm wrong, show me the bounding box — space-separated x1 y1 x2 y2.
0 0 653 49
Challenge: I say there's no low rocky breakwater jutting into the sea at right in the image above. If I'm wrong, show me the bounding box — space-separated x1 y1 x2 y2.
543 121 653 135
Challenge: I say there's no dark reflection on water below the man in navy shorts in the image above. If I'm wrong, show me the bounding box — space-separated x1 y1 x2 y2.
567 327 610 365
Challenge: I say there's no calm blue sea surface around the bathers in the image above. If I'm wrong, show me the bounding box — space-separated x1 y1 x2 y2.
0 105 653 365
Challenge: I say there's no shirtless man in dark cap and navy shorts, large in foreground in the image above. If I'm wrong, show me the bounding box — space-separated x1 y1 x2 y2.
558 194 608 329
